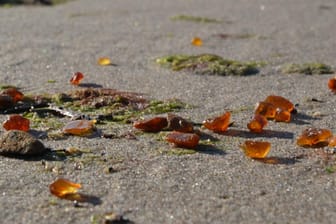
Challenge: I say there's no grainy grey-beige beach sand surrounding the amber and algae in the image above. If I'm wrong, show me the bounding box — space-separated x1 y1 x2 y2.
0 0 336 224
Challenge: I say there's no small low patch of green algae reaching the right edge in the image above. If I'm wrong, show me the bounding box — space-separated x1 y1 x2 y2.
281 62 334 75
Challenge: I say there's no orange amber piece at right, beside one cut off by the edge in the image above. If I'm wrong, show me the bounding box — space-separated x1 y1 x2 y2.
296 128 332 147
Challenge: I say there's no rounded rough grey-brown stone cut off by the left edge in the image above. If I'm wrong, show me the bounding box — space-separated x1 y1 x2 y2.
0 130 47 156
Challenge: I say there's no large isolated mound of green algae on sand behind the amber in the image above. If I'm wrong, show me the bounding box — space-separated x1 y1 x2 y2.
156 54 266 76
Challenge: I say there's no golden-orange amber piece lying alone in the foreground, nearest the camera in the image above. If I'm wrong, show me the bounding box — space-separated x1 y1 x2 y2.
49 178 82 198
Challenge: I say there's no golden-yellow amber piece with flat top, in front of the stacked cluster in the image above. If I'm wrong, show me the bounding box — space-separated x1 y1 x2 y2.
240 140 271 159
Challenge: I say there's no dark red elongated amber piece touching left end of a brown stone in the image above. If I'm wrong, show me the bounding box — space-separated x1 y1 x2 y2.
133 117 168 132
